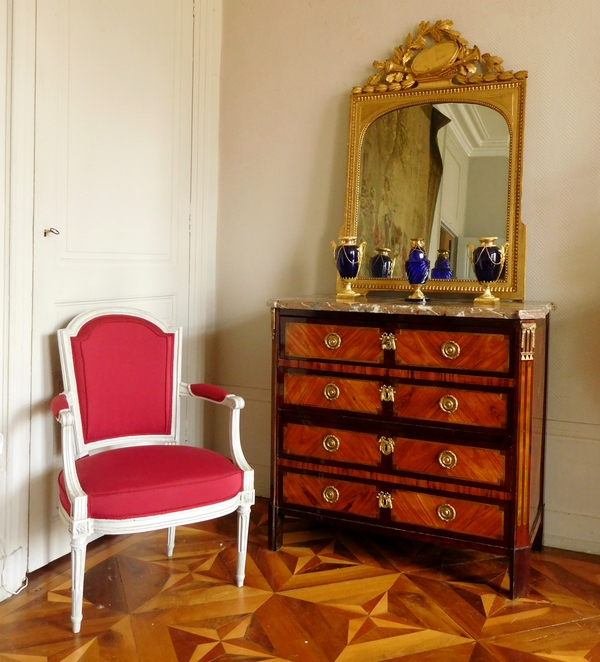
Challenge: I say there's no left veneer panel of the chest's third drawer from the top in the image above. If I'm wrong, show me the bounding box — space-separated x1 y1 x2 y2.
283 423 381 466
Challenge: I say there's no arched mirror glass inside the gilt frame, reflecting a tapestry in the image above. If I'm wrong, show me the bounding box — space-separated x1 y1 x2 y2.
357 103 510 280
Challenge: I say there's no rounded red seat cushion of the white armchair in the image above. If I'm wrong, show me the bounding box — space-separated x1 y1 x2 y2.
58 446 244 519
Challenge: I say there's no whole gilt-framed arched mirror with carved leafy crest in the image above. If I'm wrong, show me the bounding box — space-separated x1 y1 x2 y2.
337 20 527 300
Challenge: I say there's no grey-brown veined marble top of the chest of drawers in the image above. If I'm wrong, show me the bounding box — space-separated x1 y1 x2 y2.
268 294 555 320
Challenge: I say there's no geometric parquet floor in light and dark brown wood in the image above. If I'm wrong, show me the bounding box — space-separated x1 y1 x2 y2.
0 502 600 662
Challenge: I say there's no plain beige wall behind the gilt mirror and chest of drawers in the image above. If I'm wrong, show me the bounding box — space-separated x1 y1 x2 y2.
212 0 600 552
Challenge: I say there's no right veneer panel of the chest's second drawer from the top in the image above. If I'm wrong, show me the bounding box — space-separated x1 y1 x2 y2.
394 384 508 428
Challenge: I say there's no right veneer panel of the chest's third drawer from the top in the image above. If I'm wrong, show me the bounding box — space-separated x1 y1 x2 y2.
393 439 506 485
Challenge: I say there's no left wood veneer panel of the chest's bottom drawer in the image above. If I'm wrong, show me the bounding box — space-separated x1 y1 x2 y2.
283 471 379 518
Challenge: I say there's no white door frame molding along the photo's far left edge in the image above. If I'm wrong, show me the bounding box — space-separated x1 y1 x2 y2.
0 0 36 597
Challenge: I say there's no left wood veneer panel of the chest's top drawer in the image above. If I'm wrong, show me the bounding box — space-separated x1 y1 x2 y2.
284 322 383 363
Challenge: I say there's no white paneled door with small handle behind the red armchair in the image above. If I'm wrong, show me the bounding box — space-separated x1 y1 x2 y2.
29 0 194 570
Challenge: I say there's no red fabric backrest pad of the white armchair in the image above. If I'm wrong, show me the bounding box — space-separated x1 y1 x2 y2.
71 315 174 443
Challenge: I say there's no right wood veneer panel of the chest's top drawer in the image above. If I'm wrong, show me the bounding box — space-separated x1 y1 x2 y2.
396 329 510 373
